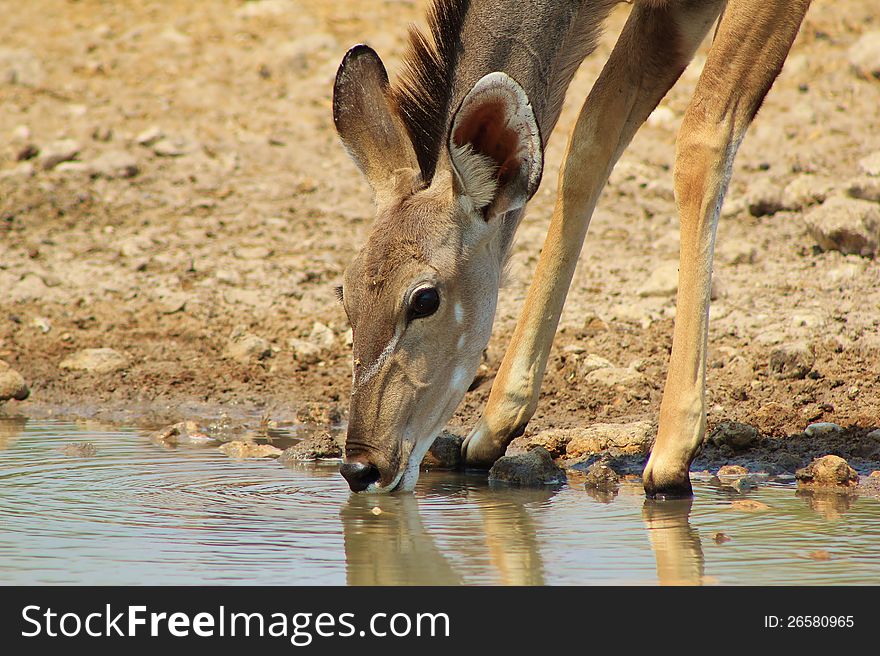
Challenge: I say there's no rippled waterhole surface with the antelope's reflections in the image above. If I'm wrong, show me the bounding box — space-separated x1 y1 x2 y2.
0 419 880 585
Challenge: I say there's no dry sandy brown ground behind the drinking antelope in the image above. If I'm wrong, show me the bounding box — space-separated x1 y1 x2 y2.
0 0 880 472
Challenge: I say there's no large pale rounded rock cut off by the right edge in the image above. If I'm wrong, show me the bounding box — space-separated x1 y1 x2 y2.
804 197 880 257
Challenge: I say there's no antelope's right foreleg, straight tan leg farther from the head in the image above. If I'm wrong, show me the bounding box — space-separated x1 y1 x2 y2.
644 0 809 496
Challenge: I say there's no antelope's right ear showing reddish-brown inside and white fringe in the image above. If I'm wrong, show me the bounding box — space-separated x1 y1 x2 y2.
447 72 544 220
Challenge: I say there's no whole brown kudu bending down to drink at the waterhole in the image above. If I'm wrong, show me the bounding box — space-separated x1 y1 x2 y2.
333 0 809 497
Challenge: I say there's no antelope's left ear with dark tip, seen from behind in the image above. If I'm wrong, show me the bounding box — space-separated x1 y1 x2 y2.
333 45 418 195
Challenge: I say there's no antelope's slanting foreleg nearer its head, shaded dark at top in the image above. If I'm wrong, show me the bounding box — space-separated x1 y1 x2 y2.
463 0 722 466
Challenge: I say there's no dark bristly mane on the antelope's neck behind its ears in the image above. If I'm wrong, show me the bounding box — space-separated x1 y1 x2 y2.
391 0 470 184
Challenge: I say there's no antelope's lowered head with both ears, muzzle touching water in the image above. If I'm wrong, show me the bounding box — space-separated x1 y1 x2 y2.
333 46 543 492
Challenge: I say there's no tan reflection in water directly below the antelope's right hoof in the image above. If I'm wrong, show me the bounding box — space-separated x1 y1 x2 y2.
642 499 704 585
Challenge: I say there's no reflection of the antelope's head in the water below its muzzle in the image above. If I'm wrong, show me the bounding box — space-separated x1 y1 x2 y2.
340 494 462 585
